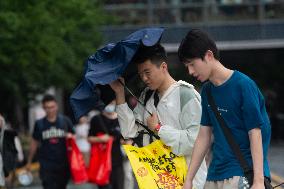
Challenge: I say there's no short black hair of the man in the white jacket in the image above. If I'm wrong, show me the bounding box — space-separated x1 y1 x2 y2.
132 43 167 66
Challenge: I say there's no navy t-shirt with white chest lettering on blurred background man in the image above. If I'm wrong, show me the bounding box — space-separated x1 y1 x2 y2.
32 115 74 170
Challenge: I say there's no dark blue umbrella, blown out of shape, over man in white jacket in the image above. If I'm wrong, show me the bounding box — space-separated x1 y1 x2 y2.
70 28 164 120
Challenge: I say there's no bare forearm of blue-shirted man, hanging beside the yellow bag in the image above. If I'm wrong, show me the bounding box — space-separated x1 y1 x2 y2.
183 126 212 189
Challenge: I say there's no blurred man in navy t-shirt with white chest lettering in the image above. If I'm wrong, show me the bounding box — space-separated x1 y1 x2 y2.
27 95 74 189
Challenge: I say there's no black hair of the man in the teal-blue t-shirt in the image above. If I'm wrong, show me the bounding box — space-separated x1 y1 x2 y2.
178 29 220 62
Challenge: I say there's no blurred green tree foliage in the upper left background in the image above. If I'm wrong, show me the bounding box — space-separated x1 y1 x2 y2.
0 0 110 126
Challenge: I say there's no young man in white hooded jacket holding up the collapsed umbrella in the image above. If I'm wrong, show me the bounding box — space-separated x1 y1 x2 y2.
110 44 207 189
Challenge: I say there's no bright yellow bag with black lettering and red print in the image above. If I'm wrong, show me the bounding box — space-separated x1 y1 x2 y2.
123 140 187 189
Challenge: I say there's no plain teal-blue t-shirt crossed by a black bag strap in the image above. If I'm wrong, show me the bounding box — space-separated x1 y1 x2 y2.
201 71 271 181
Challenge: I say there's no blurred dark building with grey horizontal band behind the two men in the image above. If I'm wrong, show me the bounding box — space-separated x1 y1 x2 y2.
102 0 284 140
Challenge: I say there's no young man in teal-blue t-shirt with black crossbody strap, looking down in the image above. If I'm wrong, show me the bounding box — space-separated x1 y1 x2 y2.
178 29 271 189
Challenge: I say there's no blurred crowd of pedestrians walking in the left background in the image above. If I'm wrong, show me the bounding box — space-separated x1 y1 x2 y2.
0 94 138 189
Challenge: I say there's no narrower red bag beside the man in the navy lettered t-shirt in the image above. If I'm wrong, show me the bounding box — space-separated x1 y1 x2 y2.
66 138 88 184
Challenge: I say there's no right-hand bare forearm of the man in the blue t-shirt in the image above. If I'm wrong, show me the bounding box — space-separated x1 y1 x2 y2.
249 128 264 188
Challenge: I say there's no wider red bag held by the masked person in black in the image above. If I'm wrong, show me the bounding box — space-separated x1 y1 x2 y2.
88 137 113 186
